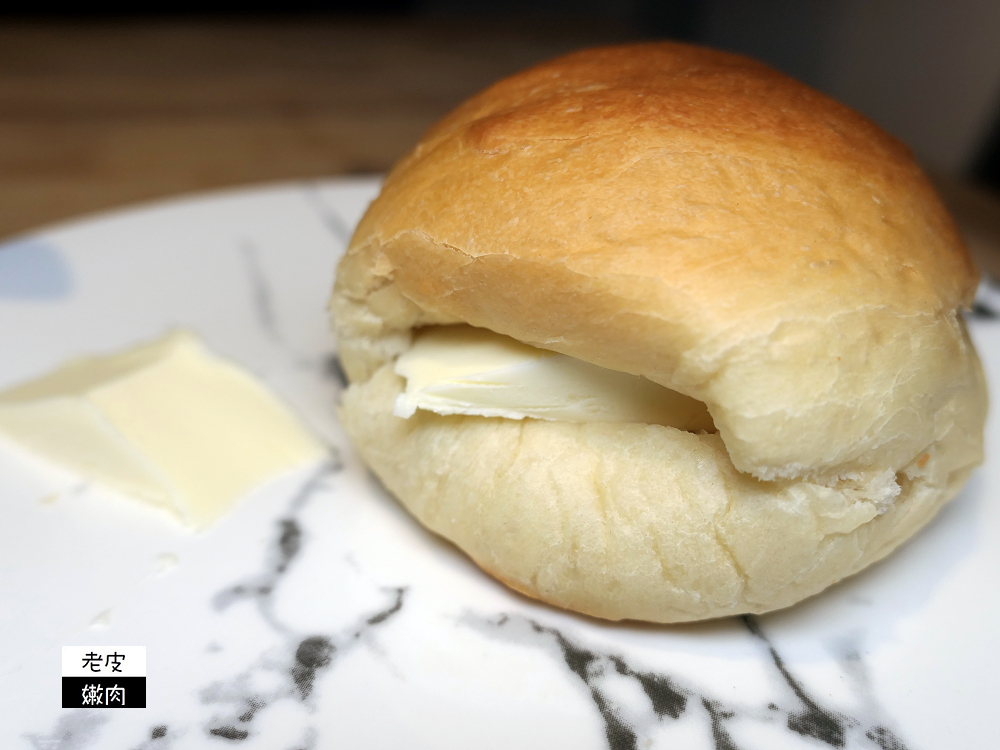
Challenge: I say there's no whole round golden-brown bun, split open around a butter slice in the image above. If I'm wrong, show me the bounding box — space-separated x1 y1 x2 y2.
331 44 986 622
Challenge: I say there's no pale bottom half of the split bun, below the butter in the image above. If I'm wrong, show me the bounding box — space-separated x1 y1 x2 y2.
340 364 985 623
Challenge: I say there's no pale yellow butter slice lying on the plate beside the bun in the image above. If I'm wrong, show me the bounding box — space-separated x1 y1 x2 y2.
0 332 327 528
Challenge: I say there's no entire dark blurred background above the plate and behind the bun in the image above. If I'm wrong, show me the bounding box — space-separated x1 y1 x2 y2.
0 0 1000 277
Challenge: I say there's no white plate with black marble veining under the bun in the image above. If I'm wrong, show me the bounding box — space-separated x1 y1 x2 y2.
0 179 1000 750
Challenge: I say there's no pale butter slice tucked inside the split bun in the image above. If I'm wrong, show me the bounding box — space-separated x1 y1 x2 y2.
393 325 715 431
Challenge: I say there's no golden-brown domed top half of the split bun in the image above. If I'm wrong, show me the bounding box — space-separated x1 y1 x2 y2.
332 43 977 480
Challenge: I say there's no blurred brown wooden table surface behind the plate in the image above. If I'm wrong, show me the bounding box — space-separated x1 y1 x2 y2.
0 19 1000 278
